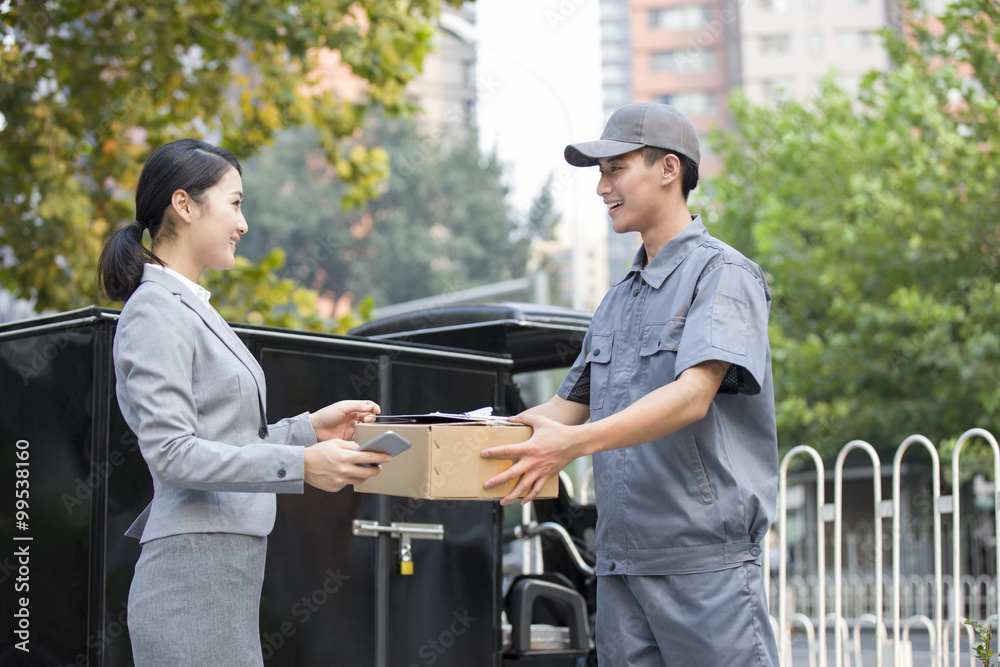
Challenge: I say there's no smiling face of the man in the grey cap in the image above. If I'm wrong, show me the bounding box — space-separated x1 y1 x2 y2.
597 150 664 234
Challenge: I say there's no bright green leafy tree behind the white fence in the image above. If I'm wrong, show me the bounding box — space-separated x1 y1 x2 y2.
711 0 1000 455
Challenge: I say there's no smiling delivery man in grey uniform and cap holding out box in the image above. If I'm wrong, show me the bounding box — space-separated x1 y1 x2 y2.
482 104 778 667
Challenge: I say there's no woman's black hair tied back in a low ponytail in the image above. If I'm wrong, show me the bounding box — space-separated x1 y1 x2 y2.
97 139 243 301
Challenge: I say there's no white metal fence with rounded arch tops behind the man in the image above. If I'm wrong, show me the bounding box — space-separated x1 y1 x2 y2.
764 428 1000 667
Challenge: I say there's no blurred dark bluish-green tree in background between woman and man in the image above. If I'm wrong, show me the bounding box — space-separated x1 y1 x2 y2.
241 118 530 305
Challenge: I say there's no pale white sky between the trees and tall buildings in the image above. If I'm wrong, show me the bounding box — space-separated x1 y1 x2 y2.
474 0 607 240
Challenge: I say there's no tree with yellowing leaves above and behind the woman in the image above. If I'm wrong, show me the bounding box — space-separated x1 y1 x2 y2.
0 0 461 318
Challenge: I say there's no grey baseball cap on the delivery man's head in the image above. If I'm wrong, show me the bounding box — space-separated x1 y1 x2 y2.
563 102 701 167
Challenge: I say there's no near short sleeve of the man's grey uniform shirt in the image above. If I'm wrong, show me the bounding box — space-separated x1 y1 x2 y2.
674 263 771 394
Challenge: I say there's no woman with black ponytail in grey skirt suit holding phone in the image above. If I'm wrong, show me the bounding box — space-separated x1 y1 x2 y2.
98 139 390 667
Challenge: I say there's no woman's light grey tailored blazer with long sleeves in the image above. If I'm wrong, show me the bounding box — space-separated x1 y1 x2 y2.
114 265 316 542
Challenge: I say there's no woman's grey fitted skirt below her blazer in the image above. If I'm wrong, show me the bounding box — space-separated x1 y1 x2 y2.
128 533 267 667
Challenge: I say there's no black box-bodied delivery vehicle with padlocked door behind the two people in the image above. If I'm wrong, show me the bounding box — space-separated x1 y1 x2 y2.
0 303 597 667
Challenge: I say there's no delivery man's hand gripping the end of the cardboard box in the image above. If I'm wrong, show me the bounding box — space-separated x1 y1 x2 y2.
481 413 589 505
